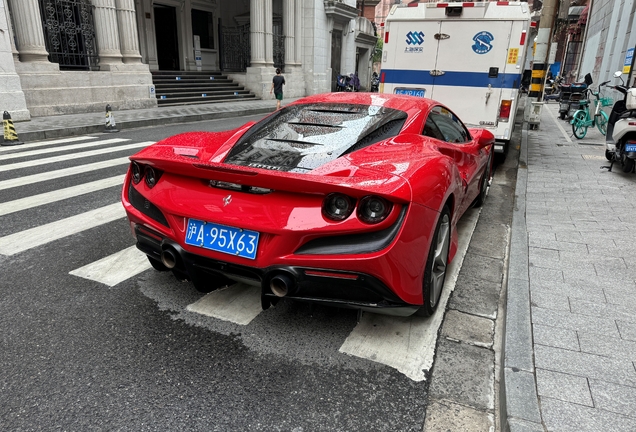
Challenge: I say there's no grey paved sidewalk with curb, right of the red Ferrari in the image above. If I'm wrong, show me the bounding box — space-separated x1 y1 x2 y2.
504 99 636 432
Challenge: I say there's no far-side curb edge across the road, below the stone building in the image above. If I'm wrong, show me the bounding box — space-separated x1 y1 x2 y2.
14 107 272 142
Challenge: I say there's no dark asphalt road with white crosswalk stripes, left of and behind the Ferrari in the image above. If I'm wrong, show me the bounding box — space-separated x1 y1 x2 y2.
0 116 512 432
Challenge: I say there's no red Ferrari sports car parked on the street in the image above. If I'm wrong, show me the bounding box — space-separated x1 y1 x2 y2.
122 93 494 316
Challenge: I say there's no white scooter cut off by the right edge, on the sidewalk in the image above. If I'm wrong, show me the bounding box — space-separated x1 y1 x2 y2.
602 71 636 173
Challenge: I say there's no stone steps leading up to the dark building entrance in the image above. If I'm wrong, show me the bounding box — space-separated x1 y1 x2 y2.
152 71 258 106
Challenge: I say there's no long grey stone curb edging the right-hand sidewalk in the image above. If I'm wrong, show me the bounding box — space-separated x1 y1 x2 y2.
500 122 545 432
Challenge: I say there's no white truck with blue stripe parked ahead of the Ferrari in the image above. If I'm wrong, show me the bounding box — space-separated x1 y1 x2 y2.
379 1 530 153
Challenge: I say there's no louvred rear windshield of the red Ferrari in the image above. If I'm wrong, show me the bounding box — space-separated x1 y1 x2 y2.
225 104 407 172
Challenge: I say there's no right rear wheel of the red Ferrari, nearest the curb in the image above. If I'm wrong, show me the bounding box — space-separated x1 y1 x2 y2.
415 205 451 317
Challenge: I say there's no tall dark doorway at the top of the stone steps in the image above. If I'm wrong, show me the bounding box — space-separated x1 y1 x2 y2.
154 4 181 71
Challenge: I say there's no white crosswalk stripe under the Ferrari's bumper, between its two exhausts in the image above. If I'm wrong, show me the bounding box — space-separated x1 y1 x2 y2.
186 283 263 325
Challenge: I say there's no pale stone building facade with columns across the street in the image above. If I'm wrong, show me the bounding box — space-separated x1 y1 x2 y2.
0 0 376 120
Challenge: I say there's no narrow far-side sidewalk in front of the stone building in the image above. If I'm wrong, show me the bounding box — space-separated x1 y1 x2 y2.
9 99 295 143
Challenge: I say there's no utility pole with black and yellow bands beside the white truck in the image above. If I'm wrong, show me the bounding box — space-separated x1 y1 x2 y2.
528 0 559 101
